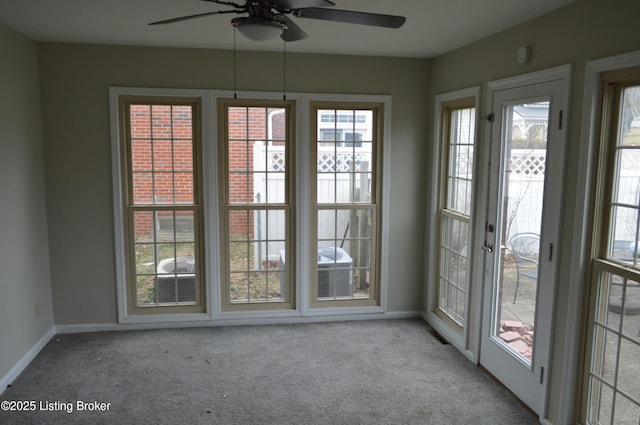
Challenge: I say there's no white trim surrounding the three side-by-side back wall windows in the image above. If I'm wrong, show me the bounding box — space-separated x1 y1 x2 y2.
109 87 392 327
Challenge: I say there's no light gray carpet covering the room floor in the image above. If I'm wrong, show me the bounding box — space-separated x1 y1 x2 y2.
0 320 538 425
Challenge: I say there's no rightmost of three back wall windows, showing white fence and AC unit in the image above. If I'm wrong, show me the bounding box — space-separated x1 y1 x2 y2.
309 102 382 307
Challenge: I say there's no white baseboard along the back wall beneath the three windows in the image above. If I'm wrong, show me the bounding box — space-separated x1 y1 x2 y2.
56 311 421 334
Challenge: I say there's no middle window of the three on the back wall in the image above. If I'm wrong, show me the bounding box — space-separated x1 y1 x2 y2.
218 100 296 310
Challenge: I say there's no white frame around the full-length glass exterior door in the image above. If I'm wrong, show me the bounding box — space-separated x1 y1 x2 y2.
474 64 572 418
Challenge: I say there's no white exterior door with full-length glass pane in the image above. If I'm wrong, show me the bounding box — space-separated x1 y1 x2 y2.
478 67 569 415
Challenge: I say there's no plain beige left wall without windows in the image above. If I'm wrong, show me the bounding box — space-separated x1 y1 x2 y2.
0 25 53 380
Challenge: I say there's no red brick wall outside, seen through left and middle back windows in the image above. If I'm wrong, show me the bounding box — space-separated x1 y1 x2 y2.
129 104 285 238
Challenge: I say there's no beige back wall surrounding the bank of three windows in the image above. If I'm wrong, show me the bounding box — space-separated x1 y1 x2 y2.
38 43 428 324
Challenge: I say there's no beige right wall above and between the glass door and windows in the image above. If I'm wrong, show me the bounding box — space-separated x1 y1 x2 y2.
428 0 640 423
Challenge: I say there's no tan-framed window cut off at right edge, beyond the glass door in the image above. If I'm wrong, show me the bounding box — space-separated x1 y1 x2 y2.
585 68 640 424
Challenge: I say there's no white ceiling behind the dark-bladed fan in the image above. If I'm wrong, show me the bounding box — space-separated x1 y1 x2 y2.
0 0 574 58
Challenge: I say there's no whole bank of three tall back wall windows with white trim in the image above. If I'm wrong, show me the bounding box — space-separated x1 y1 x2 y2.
110 87 390 323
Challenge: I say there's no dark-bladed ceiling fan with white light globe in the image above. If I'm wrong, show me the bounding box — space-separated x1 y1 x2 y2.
149 0 405 41
